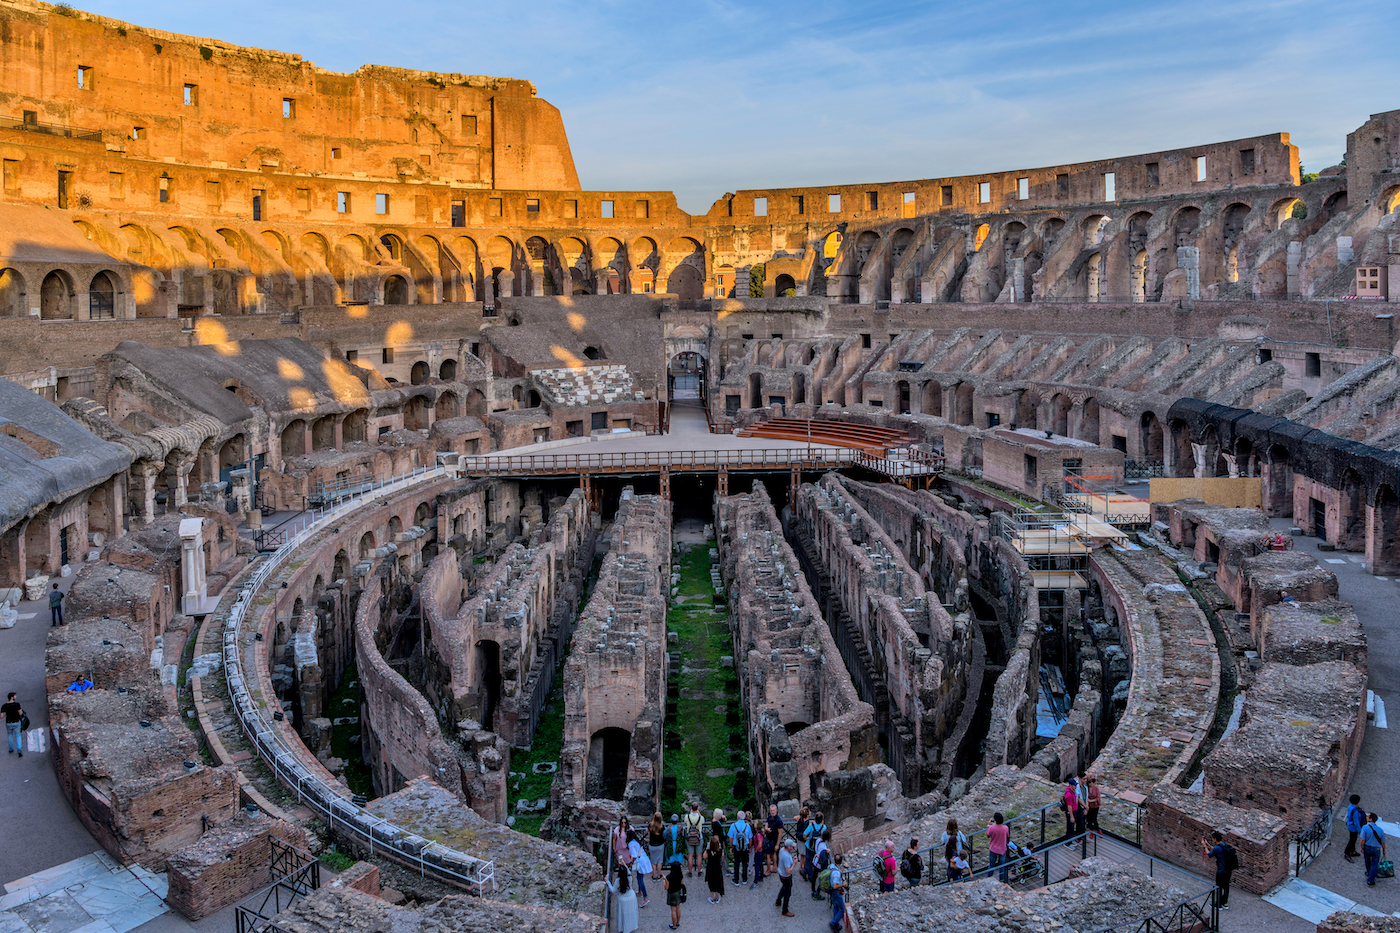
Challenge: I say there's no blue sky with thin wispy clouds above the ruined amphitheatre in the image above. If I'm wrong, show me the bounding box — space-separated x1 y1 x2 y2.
74 0 1400 213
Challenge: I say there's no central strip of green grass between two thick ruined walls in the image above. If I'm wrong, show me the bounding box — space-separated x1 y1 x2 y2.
662 545 752 818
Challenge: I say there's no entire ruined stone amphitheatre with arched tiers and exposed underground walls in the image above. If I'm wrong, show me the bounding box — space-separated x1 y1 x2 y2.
0 0 1400 933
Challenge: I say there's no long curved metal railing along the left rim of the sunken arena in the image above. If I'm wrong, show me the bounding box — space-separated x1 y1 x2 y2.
224 467 496 894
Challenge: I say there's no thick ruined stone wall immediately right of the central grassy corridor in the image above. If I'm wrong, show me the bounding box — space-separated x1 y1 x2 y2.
715 483 879 827
